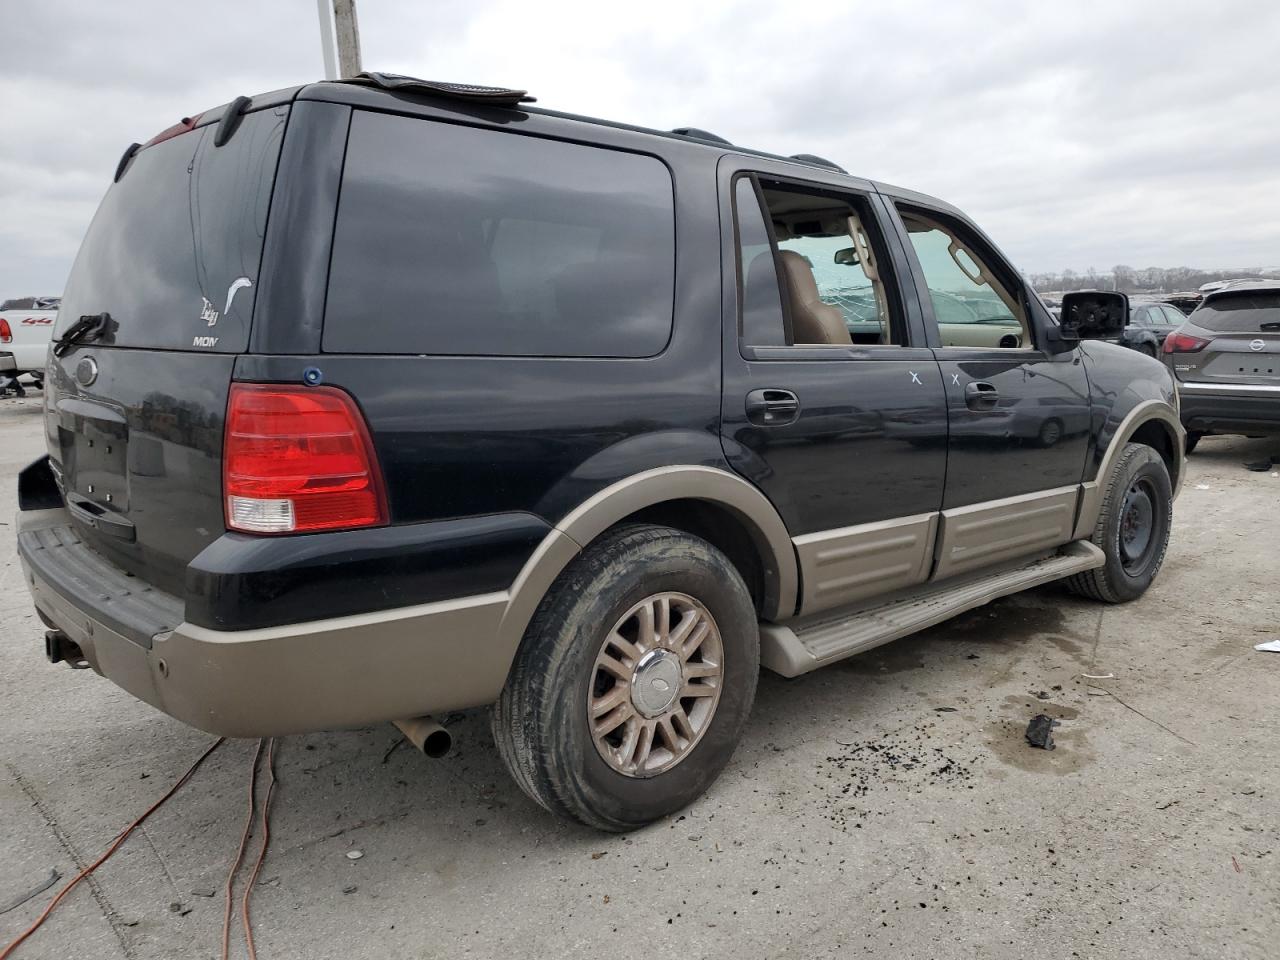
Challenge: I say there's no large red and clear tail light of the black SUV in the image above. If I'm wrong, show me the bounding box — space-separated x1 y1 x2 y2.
223 384 387 534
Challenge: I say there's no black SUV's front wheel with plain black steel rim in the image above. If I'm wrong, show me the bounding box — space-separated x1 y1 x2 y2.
1066 443 1174 603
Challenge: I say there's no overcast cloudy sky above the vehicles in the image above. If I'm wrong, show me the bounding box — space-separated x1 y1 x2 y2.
0 0 1280 298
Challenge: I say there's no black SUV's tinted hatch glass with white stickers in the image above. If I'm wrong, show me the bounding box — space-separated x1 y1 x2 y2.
55 106 288 353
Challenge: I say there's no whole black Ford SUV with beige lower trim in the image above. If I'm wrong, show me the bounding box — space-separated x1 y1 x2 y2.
18 76 1184 829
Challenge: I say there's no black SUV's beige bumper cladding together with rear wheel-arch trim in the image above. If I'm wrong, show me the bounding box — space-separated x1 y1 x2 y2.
18 466 799 736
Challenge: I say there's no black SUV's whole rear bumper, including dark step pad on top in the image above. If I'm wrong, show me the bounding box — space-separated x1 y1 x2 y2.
18 508 515 737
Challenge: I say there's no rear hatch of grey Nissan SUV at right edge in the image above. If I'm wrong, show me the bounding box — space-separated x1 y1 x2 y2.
1174 287 1280 385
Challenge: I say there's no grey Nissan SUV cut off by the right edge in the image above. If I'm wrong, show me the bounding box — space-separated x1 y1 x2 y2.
1164 280 1280 453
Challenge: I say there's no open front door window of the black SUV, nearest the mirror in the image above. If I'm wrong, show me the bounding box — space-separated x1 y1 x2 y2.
900 210 1033 349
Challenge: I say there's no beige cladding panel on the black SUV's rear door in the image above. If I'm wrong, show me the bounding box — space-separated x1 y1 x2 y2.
795 513 938 616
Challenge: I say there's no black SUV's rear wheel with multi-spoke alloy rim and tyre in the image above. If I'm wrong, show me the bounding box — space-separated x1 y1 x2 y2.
493 525 760 831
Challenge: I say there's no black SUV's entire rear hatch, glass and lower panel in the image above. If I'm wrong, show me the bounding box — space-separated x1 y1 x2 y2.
45 99 288 595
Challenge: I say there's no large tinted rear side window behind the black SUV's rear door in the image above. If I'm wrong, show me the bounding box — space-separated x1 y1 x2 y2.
324 111 675 357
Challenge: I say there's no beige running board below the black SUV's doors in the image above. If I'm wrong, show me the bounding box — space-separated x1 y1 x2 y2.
760 540 1106 677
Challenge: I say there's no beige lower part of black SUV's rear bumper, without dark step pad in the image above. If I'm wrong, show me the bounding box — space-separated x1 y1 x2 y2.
27 560 512 737
